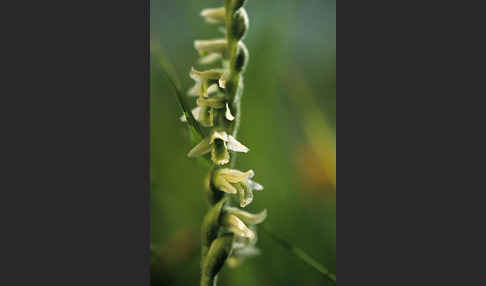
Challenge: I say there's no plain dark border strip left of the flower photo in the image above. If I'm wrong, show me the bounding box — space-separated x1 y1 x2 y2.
0 0 150 286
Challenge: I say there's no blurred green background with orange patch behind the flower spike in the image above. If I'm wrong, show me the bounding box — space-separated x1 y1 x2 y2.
150 0 336 286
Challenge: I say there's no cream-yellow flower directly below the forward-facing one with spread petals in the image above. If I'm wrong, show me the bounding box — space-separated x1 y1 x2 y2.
213 168 263 208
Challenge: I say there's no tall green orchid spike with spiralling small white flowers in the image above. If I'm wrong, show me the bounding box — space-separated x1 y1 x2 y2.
181 0 267 286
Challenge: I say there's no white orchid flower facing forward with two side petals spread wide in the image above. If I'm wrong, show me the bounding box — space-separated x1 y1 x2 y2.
187 131 249 165
